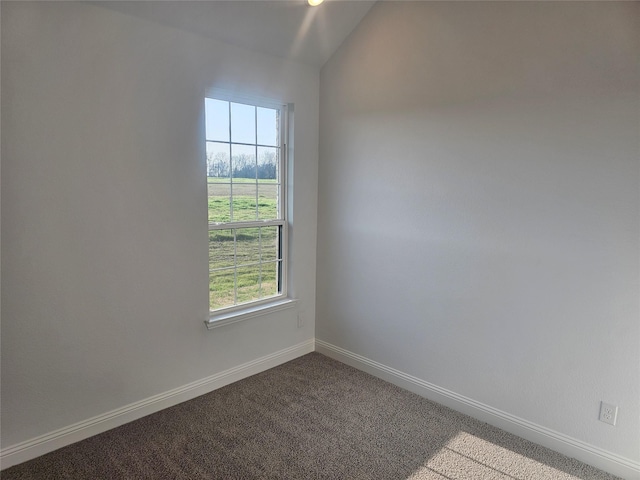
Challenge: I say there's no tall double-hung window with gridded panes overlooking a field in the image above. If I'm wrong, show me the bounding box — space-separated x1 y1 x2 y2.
205 98 287 318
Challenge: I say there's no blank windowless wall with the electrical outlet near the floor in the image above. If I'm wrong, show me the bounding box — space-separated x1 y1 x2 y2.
316 2 640 472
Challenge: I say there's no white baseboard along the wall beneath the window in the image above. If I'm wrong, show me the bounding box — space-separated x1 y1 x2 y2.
0 339 315 469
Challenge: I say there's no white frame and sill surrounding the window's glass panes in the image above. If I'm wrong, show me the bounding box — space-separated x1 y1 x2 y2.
205 91 295 329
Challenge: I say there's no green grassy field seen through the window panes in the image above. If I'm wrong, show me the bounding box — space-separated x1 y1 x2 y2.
208 177 280 310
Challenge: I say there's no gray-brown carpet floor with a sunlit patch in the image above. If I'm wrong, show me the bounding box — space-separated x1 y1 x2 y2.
1 353 616 480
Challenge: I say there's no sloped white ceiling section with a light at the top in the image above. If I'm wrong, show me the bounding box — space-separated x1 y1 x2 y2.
94 0 375 67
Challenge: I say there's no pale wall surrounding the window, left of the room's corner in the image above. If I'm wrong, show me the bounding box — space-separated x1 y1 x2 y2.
1 2 319 454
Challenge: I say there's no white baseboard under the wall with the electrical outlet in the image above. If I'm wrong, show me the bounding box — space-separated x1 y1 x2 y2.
316 339 640 480
